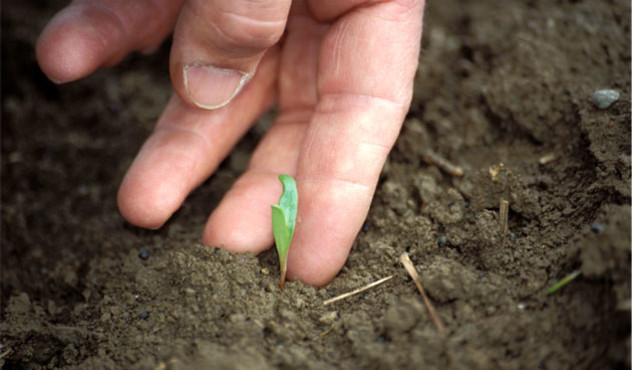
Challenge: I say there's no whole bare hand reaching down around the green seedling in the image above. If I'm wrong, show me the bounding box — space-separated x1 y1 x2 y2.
36 0 424 286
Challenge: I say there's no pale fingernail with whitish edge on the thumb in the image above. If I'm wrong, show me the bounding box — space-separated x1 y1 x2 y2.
183 64 251 109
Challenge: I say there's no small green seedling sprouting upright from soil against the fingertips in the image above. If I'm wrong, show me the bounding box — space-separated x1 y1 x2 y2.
272 175 298 290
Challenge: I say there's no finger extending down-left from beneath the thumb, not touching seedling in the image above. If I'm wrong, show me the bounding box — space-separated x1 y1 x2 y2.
118 49 278 229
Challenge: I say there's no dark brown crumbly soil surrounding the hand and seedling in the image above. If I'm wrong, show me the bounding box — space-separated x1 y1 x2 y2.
0 0 630 369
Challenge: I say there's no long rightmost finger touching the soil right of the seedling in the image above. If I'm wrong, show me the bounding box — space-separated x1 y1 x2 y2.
288 1 423 285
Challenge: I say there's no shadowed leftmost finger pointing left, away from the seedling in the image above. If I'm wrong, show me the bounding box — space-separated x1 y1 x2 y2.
36 0 184 83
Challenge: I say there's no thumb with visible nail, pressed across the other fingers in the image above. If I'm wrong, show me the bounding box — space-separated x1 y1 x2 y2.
170 0 291 109
